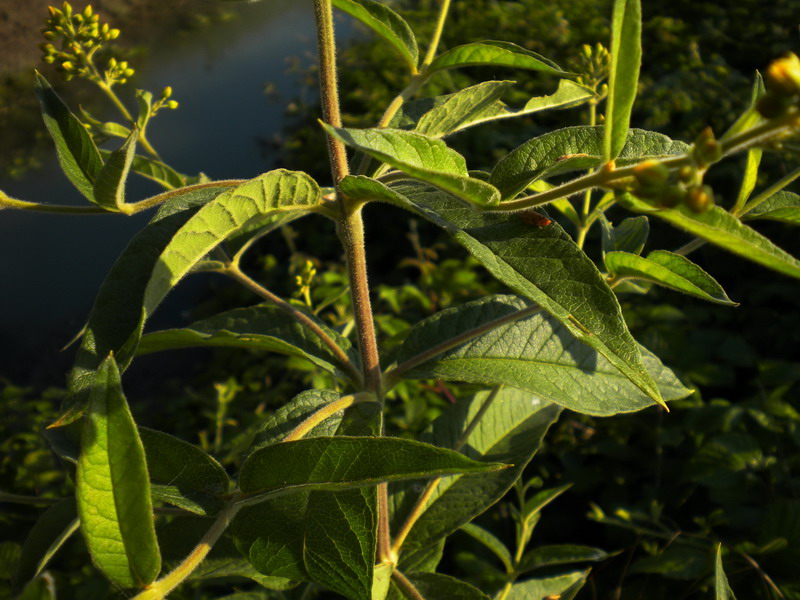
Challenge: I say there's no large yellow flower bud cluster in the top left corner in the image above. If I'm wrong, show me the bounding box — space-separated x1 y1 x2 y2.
39 2 125 84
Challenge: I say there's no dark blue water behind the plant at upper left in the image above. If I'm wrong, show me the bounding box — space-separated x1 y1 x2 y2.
0 0 348 383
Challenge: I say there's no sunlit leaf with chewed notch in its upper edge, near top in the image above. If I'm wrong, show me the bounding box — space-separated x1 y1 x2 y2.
390 79 596 137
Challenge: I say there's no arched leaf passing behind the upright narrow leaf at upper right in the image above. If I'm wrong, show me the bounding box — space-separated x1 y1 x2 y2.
489 125 689 199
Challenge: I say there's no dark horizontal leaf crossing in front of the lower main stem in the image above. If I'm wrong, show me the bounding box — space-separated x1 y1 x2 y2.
239 436 503 497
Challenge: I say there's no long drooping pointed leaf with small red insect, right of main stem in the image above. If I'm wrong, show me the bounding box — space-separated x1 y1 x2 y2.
340 177 663 403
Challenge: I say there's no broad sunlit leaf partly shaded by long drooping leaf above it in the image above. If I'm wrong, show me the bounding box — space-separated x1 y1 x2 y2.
397 296 691 415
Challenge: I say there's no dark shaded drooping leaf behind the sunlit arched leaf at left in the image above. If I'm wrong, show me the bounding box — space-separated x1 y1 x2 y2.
57 188 224 427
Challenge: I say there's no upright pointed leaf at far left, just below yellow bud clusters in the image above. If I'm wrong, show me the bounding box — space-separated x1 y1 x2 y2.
35 72 103 202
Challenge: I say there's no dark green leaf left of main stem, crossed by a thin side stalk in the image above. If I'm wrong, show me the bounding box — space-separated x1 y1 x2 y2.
137 304 358 375
